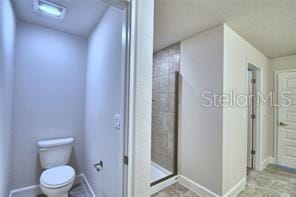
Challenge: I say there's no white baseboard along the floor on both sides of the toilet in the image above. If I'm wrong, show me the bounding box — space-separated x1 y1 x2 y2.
9 173 96 197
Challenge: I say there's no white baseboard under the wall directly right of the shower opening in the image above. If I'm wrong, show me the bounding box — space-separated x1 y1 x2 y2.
178 175 220 197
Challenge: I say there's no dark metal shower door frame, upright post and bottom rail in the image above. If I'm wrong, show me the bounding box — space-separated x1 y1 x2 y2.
150 71 180 187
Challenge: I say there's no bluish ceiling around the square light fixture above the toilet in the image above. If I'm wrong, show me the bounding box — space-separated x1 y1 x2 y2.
12 0 108 37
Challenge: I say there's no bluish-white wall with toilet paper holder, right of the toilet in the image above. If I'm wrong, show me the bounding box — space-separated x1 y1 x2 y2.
84 7 124 197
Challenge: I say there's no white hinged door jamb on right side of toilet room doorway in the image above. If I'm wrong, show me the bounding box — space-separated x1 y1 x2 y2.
115 0 134 197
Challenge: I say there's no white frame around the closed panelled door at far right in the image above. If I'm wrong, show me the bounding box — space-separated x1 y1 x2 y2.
273 69 296 164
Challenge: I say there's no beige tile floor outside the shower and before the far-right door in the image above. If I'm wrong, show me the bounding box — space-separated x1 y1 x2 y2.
153 165 296 197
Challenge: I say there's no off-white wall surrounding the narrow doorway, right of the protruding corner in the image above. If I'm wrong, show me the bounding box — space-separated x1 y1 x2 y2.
223 25 273 194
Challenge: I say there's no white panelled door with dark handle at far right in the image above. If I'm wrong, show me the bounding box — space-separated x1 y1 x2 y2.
277 72 296 168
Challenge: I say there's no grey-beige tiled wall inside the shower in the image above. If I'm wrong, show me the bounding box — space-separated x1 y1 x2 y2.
151 44 180 172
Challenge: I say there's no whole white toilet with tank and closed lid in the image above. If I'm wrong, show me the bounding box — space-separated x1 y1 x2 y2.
38 138 75 197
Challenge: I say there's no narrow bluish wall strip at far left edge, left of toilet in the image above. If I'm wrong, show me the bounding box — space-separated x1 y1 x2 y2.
0 0 16 196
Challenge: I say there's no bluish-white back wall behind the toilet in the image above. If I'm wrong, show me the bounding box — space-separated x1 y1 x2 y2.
11 23 87 189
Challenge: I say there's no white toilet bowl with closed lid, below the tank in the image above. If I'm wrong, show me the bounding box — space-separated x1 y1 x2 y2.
40 165 75 197
